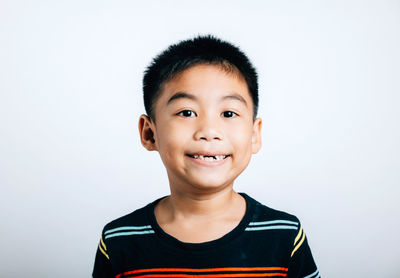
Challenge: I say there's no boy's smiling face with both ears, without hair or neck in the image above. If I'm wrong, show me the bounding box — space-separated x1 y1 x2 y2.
139 65 261 194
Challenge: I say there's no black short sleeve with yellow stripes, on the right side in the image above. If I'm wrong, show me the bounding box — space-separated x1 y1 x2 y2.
287 224 321 278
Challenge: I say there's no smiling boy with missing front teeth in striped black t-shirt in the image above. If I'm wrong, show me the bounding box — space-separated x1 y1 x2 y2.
93 36 320 278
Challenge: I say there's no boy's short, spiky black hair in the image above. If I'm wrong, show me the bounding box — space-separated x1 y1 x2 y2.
143 35 258 120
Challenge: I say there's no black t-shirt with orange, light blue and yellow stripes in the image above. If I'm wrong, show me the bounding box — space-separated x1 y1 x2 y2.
93 193 320 278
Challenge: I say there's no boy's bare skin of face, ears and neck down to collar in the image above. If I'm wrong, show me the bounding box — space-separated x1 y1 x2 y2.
139 65 262 243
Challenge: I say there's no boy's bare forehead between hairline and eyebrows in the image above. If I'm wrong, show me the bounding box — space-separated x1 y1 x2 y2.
157 64 252 106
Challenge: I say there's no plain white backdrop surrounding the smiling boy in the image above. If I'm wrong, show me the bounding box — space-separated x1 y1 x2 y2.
0 0 400 278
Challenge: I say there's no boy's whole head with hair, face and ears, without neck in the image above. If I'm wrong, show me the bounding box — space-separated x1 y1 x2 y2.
139 37 261 194
